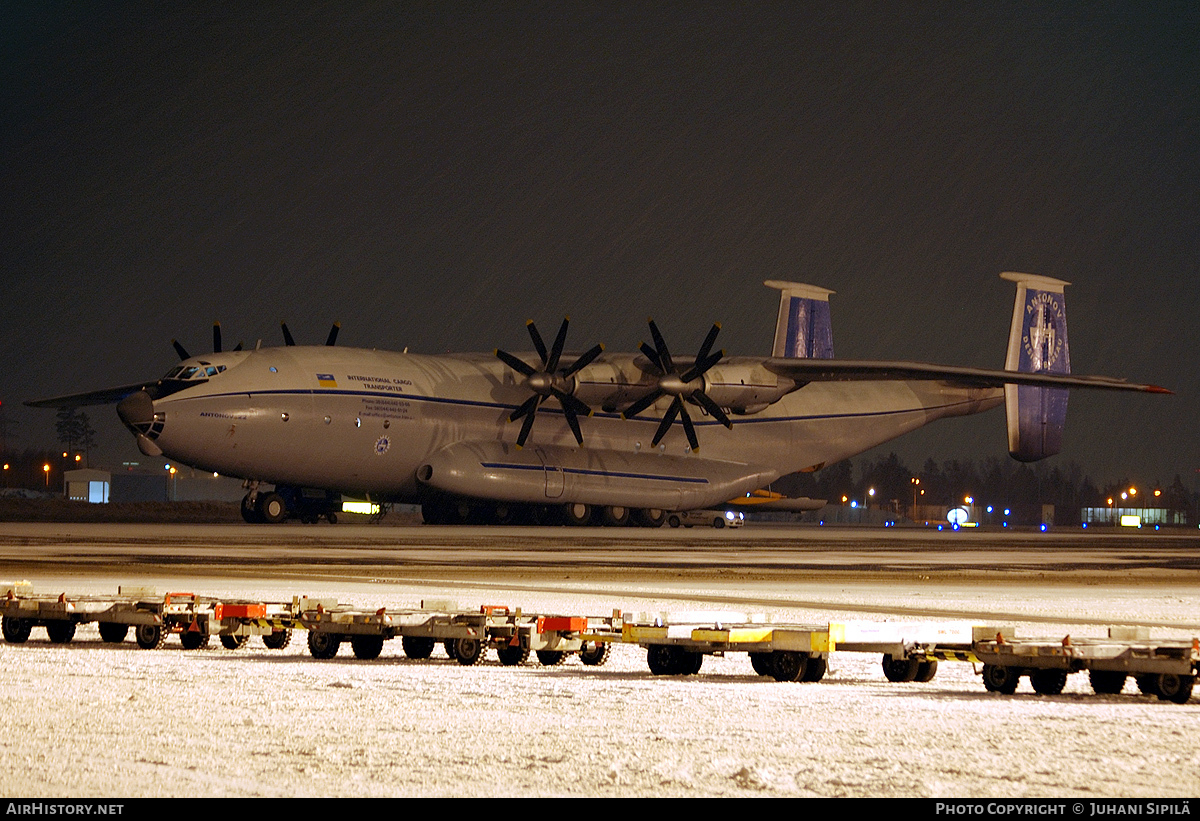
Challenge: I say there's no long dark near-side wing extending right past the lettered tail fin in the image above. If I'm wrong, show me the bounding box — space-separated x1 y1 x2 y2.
762 356 1174 394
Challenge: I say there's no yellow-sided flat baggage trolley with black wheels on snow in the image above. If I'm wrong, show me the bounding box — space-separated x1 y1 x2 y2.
622 611 834 682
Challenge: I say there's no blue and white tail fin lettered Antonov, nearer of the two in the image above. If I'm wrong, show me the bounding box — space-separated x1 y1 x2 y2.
1000 272 1070 462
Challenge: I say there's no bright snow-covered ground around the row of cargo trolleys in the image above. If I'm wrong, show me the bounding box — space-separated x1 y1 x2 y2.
0 576 1200 799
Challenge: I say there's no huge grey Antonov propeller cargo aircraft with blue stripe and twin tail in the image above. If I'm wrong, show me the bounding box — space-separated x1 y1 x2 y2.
30 274 1170 527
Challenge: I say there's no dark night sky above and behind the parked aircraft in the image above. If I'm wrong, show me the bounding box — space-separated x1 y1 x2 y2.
0 1 1200 487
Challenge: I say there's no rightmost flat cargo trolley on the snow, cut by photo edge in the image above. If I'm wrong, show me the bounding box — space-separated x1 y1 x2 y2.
974 627 1200 705
